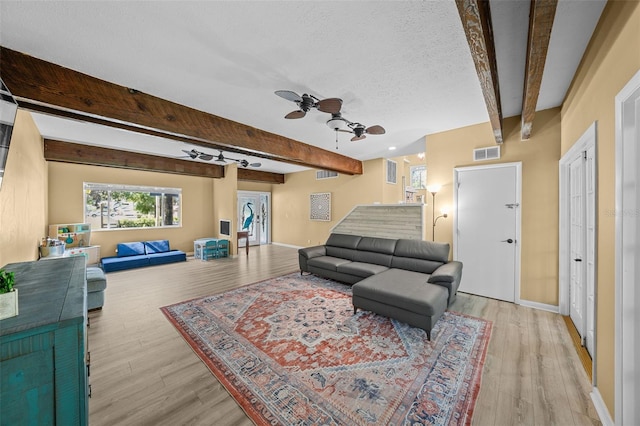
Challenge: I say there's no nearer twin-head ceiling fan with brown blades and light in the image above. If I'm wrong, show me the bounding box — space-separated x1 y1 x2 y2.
275 90 385 149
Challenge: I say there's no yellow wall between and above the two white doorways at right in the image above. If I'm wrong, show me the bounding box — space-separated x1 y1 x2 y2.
561 1 640 418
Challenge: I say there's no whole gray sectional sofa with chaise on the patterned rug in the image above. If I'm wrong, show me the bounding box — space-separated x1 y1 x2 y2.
298 234 462 339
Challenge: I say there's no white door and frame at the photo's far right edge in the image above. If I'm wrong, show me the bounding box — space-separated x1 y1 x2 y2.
613 71 640 425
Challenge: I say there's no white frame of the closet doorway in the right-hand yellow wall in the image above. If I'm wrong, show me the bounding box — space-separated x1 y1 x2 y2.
558 121 598 380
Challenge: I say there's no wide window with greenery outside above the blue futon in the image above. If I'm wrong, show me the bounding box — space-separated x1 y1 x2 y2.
84 182 182 229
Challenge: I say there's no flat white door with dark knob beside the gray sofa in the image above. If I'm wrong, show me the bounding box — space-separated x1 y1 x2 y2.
454 163 521 302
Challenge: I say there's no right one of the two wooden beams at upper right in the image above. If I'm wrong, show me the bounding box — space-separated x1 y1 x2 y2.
520 0 558 140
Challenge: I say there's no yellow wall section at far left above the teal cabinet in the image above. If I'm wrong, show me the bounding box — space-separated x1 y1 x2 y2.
0 110 48 266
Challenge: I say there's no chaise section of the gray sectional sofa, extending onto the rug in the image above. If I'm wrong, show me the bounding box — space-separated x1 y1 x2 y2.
352 269 449 340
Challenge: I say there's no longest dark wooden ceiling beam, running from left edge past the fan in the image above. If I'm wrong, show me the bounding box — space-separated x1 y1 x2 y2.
0 47 363 175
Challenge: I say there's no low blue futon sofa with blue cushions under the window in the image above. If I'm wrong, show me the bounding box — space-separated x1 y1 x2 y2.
101 240 187 272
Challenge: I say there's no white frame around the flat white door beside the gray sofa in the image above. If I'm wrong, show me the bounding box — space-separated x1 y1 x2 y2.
453 162 522 305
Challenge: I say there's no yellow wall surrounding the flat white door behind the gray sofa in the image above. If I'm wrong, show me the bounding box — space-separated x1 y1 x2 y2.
425 108 560 306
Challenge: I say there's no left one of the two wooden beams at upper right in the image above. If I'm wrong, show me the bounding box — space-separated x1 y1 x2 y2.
456 0 502 144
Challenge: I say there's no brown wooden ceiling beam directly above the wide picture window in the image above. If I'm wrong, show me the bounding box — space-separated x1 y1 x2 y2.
44 139 224 178
